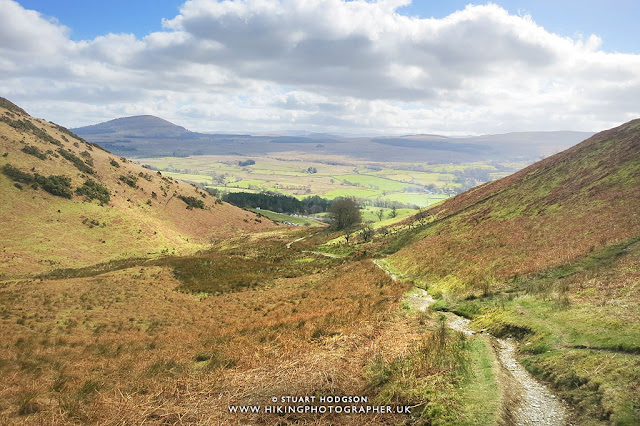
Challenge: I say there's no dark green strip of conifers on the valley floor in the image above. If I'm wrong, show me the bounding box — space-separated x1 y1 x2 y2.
223 192 331 215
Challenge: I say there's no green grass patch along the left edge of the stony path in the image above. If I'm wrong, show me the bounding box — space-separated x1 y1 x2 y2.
365 309 501 425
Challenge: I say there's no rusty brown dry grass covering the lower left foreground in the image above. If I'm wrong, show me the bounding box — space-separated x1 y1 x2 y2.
0 237 416 424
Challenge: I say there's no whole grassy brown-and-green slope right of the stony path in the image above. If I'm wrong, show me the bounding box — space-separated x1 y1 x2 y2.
383 120 640 424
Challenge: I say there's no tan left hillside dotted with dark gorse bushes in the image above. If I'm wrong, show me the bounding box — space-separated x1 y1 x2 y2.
0 98 270 276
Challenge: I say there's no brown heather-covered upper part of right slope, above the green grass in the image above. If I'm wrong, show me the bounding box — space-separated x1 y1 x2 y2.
391 120 640 290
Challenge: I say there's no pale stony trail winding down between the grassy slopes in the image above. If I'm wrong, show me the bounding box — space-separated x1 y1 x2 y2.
373 260 571 426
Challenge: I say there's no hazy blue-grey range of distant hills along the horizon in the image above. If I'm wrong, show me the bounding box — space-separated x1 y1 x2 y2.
72 115 593 163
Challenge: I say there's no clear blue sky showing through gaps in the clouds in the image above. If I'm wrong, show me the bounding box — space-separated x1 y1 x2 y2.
19 0 640 53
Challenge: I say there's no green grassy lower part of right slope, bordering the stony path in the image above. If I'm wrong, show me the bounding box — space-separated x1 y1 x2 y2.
410 238 640 425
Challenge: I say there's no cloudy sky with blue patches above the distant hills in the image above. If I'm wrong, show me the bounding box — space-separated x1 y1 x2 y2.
0 0 640 135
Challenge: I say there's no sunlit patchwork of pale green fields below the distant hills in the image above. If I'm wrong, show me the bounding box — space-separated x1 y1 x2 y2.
139 152 523 208
